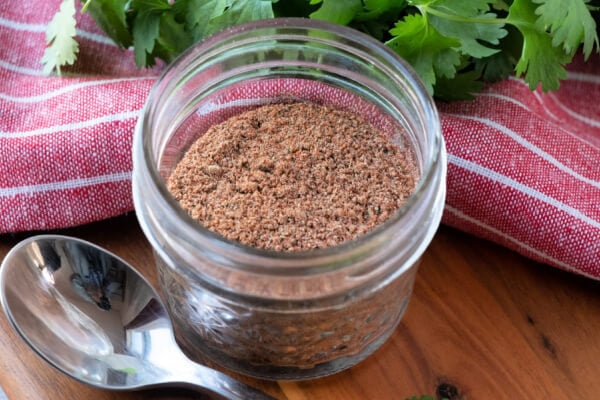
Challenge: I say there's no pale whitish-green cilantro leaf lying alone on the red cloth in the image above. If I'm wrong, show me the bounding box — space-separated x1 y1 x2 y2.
42 0 79 75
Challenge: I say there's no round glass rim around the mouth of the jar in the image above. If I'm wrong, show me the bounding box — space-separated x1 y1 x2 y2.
134 18 445 261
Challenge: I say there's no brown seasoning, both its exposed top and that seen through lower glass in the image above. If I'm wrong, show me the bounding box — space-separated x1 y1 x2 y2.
160 103 418 379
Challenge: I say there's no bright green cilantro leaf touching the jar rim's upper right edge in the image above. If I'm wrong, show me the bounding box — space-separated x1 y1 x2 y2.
386 14 460 94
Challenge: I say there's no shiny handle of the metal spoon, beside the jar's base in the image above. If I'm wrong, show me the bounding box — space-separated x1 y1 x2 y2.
164 361 277 400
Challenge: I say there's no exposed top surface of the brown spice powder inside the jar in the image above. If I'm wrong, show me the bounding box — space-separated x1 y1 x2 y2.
168 103 417 251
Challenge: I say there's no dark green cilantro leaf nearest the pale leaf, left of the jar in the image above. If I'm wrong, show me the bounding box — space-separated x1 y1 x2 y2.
82 0 133 49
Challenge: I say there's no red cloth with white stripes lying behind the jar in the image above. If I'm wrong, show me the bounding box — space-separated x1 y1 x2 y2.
0 0 600 279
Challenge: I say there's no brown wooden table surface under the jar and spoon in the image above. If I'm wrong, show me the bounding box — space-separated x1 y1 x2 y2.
0 215 600 400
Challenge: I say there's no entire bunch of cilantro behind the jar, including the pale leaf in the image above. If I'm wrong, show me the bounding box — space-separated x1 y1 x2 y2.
42 0 600 101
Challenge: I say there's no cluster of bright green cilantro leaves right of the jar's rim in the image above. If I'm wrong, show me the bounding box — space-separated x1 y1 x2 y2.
387 0 598 99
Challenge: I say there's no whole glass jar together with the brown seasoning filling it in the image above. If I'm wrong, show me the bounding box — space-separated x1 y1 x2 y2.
132 18 446 380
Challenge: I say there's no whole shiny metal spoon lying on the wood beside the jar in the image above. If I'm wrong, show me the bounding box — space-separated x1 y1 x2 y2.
0 235 273 400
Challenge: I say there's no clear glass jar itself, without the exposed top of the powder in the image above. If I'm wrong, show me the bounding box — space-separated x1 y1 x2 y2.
133 19 446 379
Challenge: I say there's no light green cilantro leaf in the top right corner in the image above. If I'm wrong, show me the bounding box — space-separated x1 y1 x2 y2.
533 0 599 59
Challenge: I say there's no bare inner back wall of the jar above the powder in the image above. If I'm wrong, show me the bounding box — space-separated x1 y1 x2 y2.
152 39 428 184
